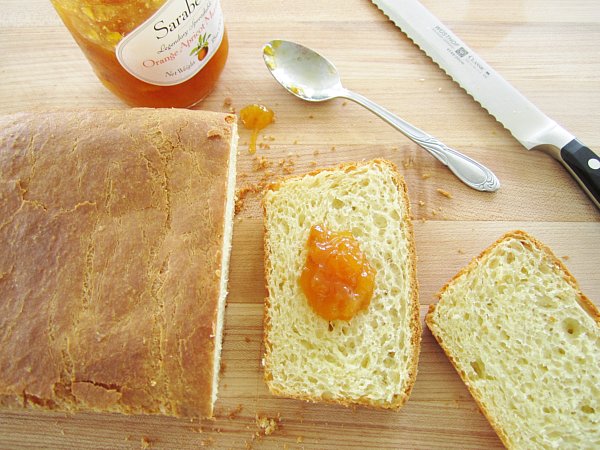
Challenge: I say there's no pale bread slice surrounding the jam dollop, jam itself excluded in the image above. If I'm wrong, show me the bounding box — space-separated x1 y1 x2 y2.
263 160 421 409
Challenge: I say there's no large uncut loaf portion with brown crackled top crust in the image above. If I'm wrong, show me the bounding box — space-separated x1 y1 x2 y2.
0 109 237 417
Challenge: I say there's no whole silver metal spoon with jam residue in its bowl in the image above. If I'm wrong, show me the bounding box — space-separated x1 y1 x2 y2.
263 40 500 192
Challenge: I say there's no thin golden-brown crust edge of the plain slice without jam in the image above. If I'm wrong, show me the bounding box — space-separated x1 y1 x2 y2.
425 230 600 448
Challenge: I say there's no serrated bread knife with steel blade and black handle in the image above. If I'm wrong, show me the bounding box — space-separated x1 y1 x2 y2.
371 0 600 208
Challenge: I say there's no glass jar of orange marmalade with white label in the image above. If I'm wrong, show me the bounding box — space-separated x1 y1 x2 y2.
52 0 228 107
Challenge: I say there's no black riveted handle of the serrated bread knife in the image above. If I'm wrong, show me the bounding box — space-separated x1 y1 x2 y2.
560 139 600 208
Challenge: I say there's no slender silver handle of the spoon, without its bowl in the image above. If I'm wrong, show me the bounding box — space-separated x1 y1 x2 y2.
338 89 500 192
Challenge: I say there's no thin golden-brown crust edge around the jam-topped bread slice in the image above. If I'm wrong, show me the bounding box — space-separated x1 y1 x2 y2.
262 159 422 410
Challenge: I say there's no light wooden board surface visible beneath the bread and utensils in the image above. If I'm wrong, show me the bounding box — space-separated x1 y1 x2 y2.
0 0 600 449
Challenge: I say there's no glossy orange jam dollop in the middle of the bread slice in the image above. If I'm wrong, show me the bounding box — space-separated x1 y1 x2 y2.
300 225 376 321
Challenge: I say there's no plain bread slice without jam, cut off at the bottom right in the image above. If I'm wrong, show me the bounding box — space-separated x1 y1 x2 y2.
426 231 600 449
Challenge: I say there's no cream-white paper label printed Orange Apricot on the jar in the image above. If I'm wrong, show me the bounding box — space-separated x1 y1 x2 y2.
115 0 225 86
